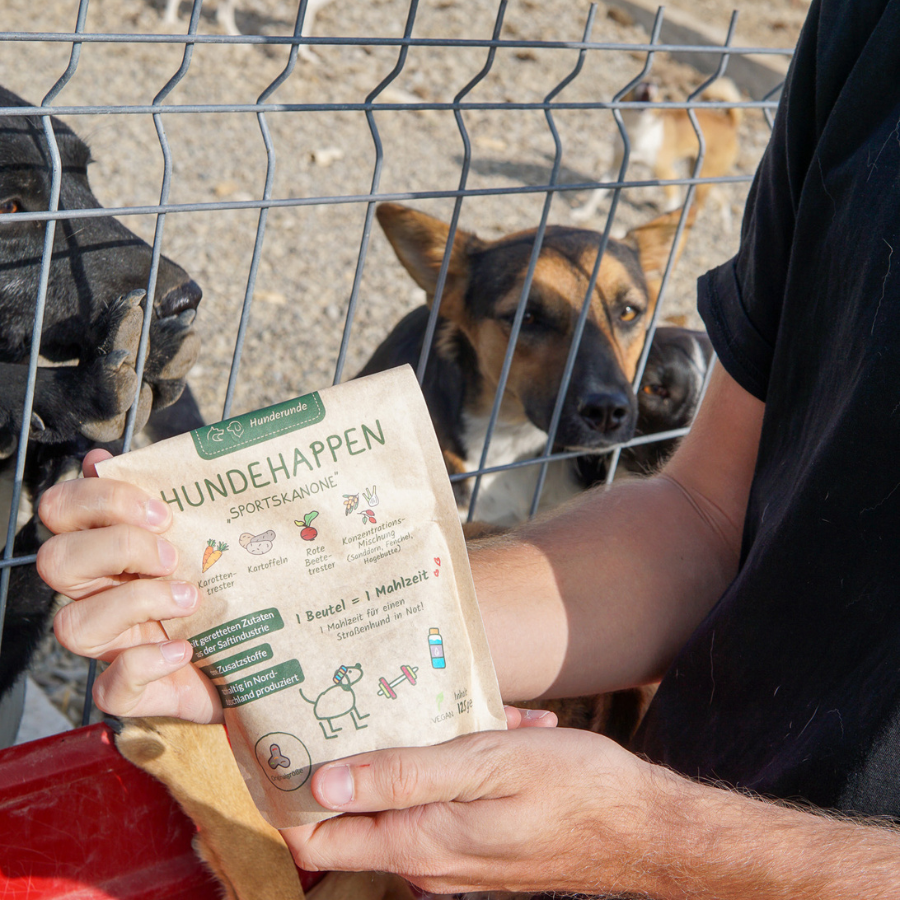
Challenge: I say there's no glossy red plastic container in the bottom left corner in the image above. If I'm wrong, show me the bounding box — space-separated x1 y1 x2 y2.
0 724 321 900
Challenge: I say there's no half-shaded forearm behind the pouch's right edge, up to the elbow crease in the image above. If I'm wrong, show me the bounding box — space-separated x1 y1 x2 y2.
470 478 737 700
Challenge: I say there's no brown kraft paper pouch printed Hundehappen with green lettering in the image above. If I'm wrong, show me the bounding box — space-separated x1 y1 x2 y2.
97 366 506 828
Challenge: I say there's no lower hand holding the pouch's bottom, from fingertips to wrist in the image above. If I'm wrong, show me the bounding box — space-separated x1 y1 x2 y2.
283 728 680 894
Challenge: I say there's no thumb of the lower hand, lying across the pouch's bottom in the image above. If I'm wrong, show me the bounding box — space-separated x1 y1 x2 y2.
310 731 514 812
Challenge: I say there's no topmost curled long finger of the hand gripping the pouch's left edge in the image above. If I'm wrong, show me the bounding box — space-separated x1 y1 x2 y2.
38 478 172 534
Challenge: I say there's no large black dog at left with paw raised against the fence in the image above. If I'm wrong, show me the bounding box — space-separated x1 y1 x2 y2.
0 88 201 696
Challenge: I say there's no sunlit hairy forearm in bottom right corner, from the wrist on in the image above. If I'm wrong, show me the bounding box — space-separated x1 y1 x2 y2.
636 770 900 900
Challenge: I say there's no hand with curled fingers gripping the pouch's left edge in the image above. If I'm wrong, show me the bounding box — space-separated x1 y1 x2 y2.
37 450 222 722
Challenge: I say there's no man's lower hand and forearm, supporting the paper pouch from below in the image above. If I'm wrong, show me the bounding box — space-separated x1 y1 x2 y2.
294 728 900 900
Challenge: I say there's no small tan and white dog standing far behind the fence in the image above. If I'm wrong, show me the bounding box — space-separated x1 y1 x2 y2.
572 78 743 222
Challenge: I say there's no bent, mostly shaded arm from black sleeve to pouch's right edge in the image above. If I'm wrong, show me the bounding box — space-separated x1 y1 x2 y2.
470 366 764 700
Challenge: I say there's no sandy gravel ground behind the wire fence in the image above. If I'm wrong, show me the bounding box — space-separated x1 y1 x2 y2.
0 0 808 720
